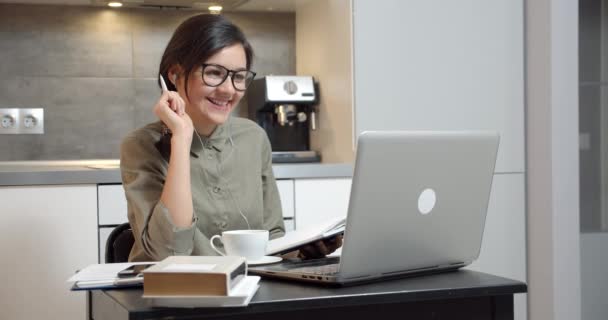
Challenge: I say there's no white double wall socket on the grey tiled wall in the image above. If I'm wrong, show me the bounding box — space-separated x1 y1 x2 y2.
0 108 44 134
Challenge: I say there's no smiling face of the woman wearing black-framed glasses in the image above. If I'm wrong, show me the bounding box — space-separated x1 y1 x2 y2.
180 44 247 135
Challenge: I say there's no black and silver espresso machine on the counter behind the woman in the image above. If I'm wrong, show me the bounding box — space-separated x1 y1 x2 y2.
247 76 321 163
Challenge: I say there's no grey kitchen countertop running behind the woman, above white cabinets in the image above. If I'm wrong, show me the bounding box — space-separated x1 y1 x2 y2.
0 160 353 186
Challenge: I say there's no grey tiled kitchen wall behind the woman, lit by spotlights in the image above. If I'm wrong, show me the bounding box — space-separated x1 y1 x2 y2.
0 5 295 161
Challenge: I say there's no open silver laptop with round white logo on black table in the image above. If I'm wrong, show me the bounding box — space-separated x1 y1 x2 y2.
249 131 499 285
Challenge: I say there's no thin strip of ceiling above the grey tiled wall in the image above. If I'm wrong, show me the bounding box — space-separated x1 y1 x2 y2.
0 0 298 12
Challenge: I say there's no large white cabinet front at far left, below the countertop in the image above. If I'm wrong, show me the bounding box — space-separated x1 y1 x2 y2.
0 184 97 320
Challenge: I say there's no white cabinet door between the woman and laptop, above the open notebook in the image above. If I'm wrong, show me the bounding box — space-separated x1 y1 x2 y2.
295 178 351 230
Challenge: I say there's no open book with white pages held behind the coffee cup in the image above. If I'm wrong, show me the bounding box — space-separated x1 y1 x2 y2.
267 217 346 255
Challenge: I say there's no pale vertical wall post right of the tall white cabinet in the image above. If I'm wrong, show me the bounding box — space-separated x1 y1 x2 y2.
526 0 581 320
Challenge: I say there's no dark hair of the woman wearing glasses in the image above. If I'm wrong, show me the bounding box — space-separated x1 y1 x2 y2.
158 14 253 95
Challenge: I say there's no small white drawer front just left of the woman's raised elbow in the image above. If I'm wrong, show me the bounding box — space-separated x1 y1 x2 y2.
97 184 129 226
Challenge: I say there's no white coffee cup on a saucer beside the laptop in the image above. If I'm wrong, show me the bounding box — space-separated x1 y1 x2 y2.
209 230 269 261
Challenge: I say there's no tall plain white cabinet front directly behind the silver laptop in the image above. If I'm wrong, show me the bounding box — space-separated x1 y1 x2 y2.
353 0 527 320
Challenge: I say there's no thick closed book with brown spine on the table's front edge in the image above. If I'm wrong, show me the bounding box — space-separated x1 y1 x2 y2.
143 256 247 297
